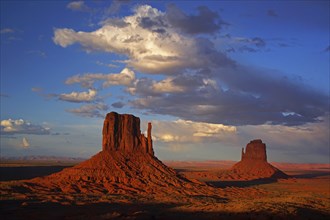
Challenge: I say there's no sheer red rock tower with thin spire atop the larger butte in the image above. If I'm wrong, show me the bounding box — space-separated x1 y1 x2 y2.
102 112 154 155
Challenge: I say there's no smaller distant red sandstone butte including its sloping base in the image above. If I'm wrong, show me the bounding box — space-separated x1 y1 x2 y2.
230 139 288 180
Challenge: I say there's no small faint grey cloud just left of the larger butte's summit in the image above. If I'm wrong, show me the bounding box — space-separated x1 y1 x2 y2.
66 103 109 118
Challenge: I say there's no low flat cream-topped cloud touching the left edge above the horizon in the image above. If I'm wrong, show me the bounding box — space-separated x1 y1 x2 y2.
1 119 50 135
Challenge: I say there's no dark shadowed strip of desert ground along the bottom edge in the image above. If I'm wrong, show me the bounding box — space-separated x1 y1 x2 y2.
0 200 329 220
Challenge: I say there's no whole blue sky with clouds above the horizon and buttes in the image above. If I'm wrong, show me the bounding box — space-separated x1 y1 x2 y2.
0 0 330 163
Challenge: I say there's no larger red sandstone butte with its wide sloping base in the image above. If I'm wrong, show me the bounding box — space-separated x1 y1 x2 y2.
25 112 215 197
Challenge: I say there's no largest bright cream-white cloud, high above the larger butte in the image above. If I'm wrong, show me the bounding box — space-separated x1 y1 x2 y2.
53 5 233 74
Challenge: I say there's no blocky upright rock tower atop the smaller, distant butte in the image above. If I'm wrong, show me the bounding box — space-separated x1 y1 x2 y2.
242 139 267 162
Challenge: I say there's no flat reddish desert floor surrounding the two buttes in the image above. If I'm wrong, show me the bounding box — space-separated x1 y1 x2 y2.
0 161 330 220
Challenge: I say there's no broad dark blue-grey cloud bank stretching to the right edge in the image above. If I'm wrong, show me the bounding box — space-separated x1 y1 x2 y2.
130 63 329 126
